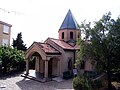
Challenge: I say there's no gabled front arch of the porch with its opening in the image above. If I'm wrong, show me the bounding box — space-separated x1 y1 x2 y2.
25 44 46 78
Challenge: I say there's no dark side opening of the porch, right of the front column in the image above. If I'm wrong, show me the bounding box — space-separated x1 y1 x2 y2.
48 57 60 77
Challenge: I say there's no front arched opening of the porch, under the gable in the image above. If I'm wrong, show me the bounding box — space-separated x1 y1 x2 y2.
29 52 44 78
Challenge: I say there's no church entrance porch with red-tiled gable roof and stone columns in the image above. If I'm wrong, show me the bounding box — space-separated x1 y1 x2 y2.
25 42 61 81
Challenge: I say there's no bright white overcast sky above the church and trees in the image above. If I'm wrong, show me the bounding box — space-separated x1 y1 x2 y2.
0 0 120 47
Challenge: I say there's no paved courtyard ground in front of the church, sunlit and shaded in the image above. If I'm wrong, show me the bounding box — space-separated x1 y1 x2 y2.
0 74 73 90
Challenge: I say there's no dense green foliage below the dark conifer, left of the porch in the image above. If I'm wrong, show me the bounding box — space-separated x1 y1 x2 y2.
0 46 25 74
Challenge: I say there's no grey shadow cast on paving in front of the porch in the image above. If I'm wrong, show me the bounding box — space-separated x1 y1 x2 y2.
16 79 73 90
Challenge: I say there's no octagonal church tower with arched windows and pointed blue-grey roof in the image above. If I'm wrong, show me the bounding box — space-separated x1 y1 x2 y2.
58 10 81 46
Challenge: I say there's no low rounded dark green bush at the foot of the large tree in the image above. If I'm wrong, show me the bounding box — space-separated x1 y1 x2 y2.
73 74 102 90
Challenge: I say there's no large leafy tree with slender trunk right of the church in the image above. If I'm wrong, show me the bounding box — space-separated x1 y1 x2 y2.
78 12 120 90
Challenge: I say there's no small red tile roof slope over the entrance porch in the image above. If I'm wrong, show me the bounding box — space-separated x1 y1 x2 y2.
35 42 60 54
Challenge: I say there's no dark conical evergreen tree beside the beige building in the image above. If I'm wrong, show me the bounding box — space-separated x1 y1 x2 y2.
12 32 27 51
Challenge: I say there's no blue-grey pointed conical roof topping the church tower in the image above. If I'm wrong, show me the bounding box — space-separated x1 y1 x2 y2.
59 10 79 30
